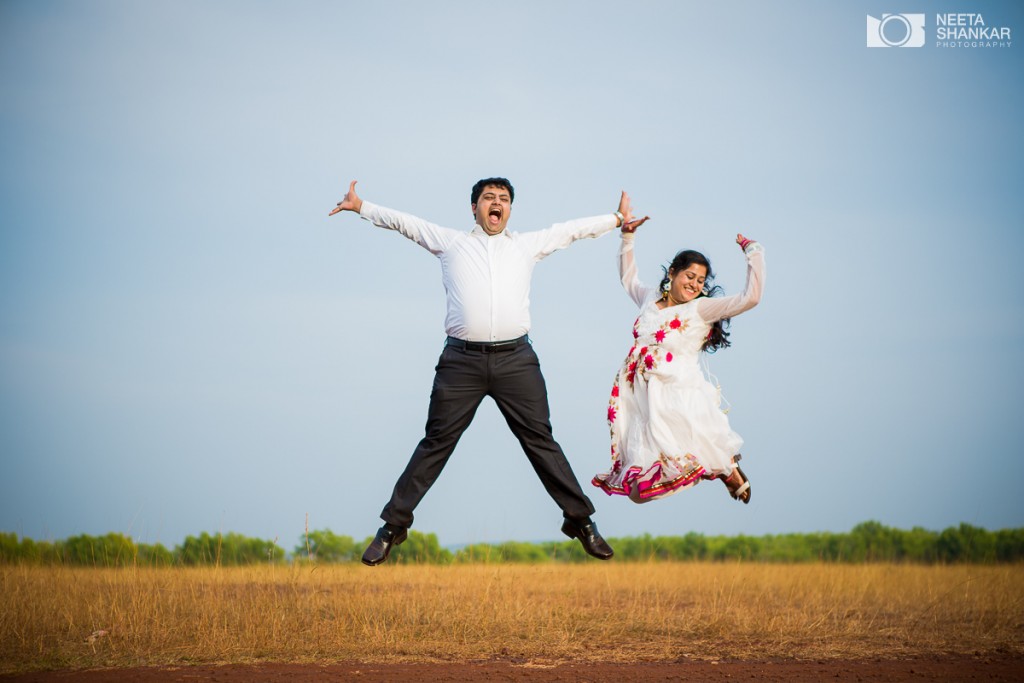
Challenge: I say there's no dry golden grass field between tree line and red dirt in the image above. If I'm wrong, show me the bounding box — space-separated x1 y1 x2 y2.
0 562 1024 672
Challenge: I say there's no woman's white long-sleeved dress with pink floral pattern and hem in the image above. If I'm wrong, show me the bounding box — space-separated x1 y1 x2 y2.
592 233 765 503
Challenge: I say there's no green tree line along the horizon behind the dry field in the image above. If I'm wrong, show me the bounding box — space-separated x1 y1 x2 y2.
0 521 1024 566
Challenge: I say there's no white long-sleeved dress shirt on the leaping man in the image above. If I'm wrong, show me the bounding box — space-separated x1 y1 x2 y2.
359 200 618 342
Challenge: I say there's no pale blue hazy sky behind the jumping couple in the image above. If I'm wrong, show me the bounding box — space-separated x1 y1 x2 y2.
0 0 1024 548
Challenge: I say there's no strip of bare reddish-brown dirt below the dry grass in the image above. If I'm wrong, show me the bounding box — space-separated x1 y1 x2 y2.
0 656 1024 683
